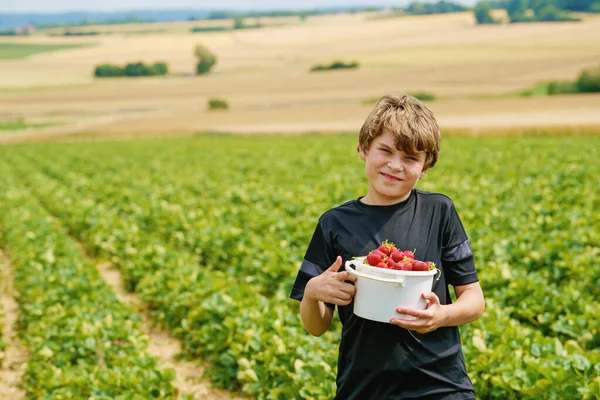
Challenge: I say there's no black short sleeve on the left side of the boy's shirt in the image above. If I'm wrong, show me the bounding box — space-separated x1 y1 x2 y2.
290 222 335 300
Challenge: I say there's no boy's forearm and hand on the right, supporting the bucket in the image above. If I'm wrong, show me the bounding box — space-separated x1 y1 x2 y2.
390 282 485 333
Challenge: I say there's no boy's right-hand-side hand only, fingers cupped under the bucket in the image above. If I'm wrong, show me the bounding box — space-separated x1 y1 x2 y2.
390 292 446 333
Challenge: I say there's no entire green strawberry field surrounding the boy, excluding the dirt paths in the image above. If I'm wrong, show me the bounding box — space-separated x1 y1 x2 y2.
0 135 600 399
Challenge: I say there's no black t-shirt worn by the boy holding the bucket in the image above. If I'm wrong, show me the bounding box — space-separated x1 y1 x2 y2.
291 189 478 400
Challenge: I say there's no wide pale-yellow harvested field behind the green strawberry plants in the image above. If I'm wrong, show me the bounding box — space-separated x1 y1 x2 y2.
0 13 600 140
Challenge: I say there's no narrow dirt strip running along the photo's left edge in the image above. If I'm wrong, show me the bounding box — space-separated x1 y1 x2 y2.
0 251 29 400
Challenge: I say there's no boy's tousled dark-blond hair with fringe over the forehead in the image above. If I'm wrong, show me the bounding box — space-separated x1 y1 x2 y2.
358 94 441 168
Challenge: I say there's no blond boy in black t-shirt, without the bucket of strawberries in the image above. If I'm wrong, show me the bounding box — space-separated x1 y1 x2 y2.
291 95 484 400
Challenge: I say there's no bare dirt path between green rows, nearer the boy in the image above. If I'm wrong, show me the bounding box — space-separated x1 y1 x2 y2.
96 262 242 400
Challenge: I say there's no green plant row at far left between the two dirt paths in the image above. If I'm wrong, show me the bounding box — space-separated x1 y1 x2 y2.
0 161 177 399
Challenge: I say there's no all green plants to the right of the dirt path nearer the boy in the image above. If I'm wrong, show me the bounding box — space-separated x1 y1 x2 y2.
1 136 600 399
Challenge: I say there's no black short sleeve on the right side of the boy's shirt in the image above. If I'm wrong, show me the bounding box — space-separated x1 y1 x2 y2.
442 204 479 286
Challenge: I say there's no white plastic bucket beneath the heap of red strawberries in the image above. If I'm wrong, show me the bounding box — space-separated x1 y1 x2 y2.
345 258 438 323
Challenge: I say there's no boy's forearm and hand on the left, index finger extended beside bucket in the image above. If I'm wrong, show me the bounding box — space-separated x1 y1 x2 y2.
300 256 356 336
